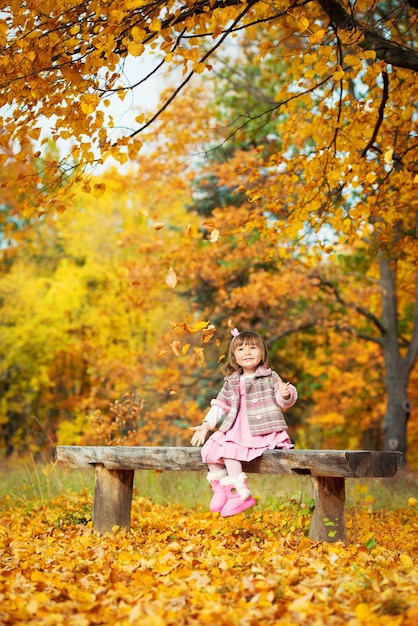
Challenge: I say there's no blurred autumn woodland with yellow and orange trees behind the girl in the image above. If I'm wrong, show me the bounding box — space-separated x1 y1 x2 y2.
0 0 418 468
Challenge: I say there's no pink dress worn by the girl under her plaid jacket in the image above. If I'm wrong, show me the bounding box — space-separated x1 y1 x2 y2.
202 377 294 464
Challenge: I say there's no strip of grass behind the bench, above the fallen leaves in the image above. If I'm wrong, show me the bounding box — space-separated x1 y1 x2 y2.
0 458 418 509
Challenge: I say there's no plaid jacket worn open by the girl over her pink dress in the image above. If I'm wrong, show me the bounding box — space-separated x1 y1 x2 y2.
211 366 298 435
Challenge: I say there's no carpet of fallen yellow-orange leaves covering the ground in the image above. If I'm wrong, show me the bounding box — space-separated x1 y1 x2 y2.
0 494 418 626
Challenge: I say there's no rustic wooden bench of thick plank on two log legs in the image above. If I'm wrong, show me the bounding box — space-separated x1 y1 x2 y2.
56 446 402 542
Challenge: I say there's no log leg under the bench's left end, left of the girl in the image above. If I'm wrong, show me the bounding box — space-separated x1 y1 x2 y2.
93 464 134 533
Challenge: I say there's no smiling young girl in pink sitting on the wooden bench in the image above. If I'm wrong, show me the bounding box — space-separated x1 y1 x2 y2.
191 328 297 517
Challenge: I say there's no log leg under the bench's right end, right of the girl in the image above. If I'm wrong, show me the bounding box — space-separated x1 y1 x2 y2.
309 476 346 542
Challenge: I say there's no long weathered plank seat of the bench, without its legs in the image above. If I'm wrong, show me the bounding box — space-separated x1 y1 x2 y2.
57 446 402 478
